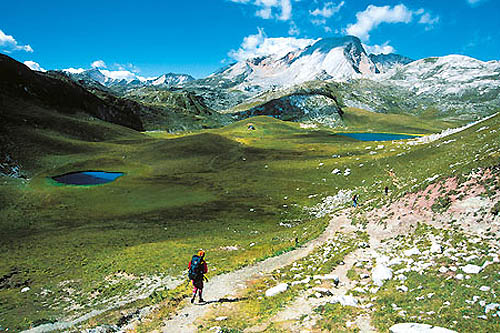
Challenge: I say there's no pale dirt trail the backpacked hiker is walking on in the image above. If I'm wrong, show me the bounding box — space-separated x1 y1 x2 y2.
161 214 344 333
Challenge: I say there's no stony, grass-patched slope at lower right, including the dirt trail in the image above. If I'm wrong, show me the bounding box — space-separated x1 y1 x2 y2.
84 168 500 332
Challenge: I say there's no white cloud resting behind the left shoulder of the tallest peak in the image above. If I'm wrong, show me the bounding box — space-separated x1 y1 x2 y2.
228 28 315 61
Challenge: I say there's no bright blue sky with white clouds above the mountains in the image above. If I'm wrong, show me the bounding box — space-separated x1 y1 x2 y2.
0 0 500 77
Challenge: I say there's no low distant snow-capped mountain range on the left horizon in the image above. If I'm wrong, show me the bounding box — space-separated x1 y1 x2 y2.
63 68 195 88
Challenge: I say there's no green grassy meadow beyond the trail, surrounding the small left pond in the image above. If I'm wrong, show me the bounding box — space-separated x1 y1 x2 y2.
0 105 500 331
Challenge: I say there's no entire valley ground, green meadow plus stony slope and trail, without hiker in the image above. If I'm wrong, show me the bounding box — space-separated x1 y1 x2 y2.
0 115 500 333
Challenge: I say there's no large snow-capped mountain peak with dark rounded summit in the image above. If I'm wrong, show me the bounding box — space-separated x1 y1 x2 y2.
208 36 392 91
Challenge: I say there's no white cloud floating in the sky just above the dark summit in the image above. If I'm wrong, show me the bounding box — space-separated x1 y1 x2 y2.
346 4 413 41
